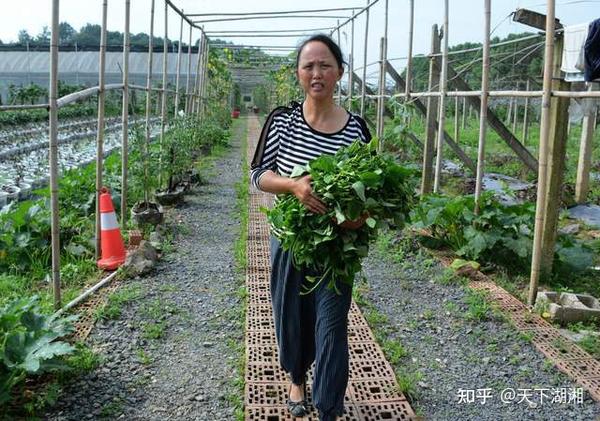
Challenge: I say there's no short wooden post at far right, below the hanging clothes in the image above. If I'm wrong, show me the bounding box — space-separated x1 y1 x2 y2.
575 84 596 204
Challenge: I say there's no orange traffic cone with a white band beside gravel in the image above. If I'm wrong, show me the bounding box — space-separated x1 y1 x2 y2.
98 187 125 270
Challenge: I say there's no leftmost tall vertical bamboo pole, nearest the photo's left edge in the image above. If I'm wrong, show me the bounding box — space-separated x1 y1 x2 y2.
48 0 61 310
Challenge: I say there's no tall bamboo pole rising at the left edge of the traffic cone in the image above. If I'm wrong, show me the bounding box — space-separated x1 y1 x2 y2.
96 0 108 259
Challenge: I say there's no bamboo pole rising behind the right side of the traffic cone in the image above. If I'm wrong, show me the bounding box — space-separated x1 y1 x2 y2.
121 0 131 227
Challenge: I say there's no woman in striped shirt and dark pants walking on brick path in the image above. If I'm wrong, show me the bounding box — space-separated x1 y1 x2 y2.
251 35 371 421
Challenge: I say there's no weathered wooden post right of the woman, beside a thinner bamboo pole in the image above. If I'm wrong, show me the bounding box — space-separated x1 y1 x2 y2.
421 25 440 196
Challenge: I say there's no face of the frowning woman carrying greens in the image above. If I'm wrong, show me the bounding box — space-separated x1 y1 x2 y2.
298 41 344 99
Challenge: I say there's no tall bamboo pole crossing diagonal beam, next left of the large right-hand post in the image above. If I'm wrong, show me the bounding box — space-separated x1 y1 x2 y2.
475 0 492 214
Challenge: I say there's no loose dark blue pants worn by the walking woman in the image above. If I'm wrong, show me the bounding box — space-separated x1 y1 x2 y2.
271 237 352 421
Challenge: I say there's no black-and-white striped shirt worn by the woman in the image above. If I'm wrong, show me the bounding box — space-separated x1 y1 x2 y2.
250 101 371 189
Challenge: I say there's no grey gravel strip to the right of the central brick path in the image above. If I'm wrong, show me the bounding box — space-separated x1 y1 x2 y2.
363 236 600 421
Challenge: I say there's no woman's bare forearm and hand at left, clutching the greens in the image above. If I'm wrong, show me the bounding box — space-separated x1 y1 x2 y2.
258 170 327 214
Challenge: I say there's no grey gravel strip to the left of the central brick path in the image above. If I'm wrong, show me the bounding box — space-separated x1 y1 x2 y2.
47 120 243 420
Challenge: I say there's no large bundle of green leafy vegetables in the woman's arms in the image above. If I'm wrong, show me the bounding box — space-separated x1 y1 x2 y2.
267 139 414 293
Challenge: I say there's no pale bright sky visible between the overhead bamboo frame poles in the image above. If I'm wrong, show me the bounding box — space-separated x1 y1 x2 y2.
0 0 600 77
